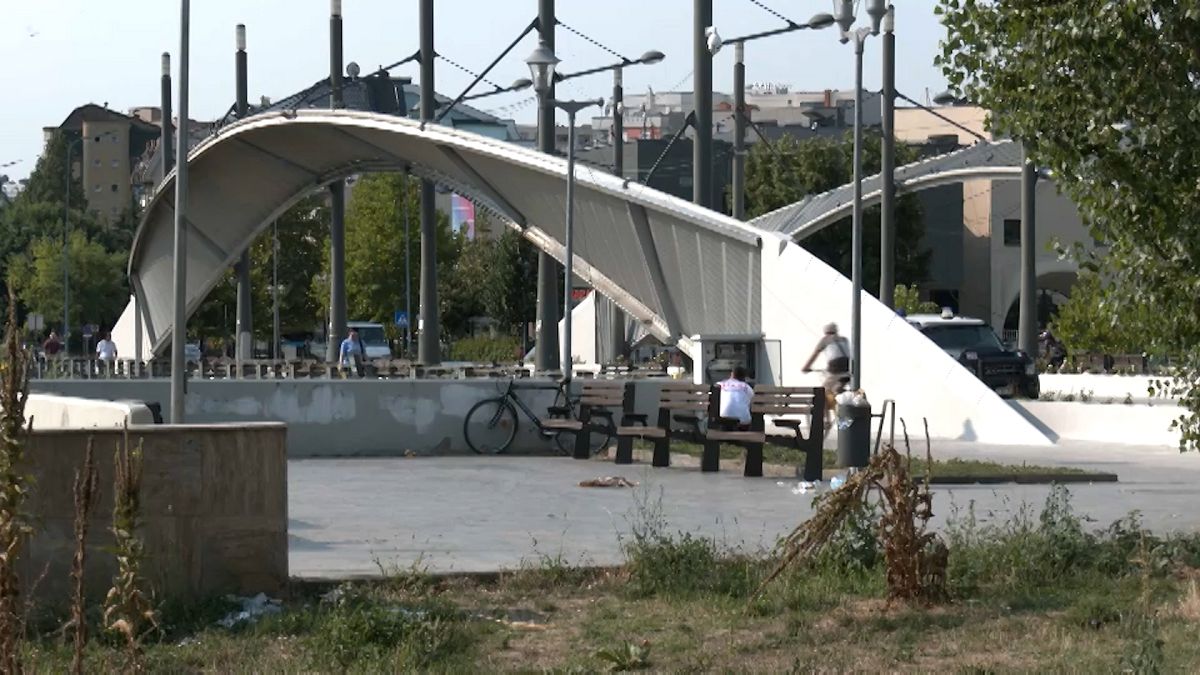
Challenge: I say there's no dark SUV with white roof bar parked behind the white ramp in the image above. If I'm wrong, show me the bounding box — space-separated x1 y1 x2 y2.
908 312 1042 399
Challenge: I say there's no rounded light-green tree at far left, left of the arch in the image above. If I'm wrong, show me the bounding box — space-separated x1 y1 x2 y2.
7 229 128 327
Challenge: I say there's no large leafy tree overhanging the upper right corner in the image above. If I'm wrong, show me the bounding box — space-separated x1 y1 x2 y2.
937 0 1200 449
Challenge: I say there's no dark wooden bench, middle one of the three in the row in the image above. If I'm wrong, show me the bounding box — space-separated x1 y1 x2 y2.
616 382 712 467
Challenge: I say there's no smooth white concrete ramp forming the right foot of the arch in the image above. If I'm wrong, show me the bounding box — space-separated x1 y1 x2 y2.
762 235 1054 446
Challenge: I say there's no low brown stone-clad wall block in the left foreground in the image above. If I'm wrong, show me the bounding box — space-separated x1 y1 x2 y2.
22 424 288 607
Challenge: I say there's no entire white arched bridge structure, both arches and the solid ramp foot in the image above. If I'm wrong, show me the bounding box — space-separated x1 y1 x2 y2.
114 110 1050 444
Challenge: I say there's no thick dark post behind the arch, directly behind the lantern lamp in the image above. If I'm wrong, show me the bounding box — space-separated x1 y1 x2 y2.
534 0 556 372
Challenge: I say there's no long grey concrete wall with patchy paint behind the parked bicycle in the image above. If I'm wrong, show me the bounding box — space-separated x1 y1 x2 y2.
31 380 658 458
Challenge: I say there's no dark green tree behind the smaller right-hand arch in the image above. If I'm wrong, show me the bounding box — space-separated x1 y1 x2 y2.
746 132 929 292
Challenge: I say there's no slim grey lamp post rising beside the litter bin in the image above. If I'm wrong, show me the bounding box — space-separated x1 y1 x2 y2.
834 0 887 389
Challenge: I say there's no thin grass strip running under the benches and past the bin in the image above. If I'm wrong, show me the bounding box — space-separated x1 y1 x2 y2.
635 442 1102 479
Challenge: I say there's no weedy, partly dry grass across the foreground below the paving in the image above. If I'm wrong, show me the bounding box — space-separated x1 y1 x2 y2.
23 489 1200 673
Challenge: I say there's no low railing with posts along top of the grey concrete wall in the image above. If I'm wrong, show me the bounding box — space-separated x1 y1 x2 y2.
30 358 681 381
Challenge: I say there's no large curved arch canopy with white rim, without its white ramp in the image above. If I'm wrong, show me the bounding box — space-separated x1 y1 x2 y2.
119 110 761 352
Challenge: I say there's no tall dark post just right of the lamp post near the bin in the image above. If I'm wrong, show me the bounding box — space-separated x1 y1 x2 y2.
880 7 896 307
